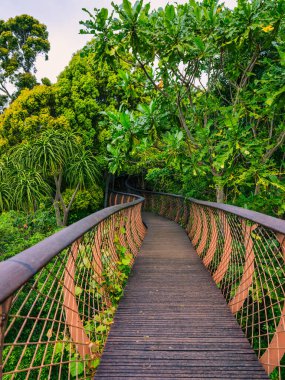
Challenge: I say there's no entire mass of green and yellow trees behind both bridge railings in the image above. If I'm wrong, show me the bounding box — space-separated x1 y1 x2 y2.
0 0 285 252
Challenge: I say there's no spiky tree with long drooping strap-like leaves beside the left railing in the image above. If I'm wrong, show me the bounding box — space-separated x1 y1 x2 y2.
0 130 99 226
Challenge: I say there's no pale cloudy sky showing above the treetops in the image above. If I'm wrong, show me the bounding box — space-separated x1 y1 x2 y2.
0 0 236 82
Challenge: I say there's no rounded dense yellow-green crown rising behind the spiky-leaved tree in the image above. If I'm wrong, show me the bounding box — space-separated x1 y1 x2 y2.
55 47 151 149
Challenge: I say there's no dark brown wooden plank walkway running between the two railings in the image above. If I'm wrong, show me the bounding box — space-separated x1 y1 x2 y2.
95 213 268 380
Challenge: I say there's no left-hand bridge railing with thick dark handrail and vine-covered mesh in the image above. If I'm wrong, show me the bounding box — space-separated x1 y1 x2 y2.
0 194 145 380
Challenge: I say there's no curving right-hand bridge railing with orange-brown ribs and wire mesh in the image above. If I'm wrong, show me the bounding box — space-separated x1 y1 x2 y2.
127 188 285 379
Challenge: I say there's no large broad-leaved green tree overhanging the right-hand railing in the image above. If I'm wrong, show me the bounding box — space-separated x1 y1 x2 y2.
82 0 285 209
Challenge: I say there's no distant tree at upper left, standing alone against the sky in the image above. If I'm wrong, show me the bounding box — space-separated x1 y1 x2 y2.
0 15 50 107
